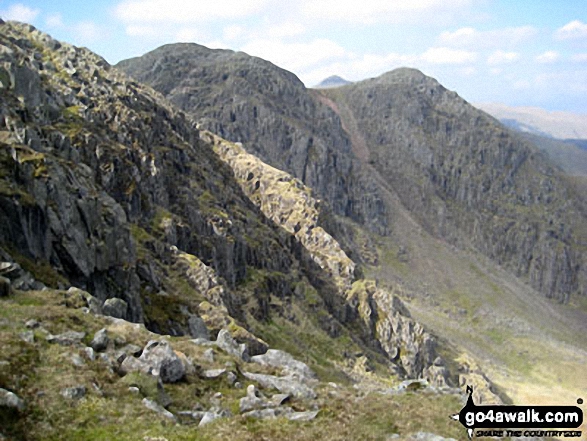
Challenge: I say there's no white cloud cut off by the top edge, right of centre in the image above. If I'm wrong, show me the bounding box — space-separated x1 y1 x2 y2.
301 0 471 24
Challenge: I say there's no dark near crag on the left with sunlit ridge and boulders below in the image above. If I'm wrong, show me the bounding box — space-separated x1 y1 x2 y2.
0 22 482 439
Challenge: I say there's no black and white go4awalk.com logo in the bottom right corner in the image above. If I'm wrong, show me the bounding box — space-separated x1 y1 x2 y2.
451 386 583 439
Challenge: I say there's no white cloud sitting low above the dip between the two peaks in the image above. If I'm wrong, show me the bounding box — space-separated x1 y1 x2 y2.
241 39 348 72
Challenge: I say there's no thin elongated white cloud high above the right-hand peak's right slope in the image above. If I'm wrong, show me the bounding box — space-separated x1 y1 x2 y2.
438 26 538 48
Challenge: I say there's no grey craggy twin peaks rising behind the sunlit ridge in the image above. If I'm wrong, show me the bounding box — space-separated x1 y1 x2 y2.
118 49 587 302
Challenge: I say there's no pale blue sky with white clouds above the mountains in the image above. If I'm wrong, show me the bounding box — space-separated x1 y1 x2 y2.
0 0 587 114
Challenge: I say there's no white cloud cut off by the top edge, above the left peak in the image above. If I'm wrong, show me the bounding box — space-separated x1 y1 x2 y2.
114 0 269 23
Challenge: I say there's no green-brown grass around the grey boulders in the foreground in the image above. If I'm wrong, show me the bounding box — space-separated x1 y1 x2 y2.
0 290 464 440
